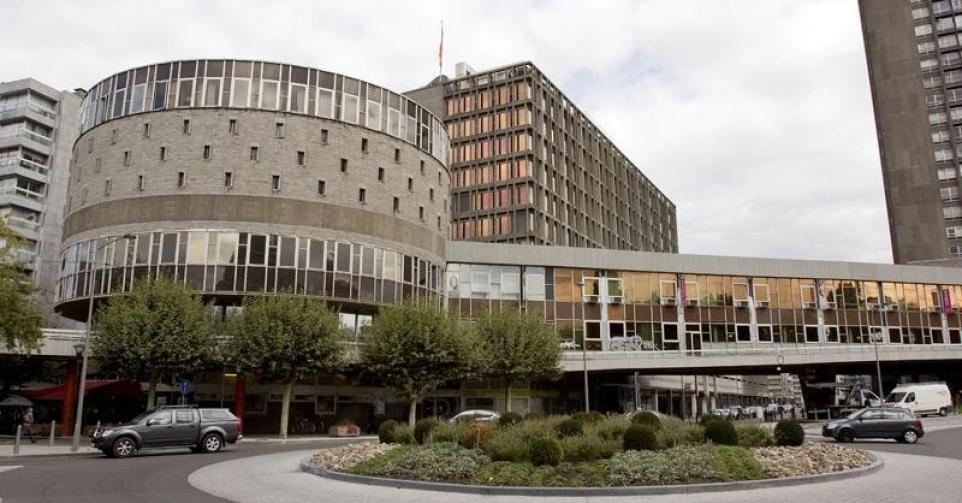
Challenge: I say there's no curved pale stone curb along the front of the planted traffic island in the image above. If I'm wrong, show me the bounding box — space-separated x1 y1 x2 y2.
301 453 882 497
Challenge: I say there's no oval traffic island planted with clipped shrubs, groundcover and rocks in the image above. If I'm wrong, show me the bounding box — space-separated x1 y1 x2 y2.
302 414 880 496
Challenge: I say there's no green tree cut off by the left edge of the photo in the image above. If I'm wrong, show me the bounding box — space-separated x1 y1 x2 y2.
0 218 43 351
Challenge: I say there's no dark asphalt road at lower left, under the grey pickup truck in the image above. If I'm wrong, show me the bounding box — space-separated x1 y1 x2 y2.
0 440 360 503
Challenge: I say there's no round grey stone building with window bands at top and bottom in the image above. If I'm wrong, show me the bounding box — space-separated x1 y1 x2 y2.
58 60 449 325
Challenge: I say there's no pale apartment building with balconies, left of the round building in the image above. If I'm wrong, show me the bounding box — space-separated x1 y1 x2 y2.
0 79 83 310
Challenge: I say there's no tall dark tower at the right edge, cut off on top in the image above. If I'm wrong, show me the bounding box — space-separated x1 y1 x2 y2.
859 0 962 265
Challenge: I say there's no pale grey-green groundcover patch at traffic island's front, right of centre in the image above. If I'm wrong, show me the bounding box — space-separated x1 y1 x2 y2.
608 446 718 486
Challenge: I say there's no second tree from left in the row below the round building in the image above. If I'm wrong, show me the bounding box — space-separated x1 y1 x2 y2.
227 295 346 438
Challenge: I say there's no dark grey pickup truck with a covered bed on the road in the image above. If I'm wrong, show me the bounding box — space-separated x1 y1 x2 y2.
91 406 240 458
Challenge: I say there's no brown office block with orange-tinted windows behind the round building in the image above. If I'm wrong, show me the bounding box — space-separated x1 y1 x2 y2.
406 62 678 252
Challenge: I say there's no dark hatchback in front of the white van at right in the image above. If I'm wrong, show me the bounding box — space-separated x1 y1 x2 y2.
822 407 925 444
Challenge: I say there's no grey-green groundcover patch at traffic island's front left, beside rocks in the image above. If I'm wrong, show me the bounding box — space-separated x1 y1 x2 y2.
350 442 491 482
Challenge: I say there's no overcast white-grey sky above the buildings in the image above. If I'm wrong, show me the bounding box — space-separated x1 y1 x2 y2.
0 0 891 262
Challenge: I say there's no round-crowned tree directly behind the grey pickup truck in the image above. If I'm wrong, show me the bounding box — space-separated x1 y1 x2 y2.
92 276 215 409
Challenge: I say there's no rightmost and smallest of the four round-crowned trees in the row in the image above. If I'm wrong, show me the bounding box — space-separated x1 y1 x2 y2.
474 309 563 412
